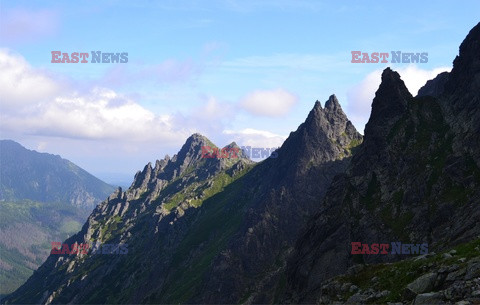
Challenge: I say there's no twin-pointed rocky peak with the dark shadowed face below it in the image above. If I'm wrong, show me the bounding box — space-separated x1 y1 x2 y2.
193 95 362 303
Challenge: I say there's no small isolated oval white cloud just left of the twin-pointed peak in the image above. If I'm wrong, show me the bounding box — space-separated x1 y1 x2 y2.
240 89 298 117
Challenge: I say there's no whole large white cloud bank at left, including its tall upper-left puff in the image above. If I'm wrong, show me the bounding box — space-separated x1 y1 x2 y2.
0 50 190 143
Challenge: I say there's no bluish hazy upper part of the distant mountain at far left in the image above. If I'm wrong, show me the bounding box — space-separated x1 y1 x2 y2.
0 140 114 210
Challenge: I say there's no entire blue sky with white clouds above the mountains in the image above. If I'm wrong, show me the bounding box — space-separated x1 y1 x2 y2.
0 0 480 185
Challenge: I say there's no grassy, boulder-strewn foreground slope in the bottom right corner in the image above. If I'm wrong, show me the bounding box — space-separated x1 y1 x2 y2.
306 239 480 304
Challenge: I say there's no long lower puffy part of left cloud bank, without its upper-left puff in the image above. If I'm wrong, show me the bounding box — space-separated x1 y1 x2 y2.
1 89 188 142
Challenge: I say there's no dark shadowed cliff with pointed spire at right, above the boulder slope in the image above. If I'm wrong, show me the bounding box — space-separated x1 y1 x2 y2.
286 24 480 302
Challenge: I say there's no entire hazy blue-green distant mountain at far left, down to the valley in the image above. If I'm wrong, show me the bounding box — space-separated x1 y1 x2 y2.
0 140 114 295
